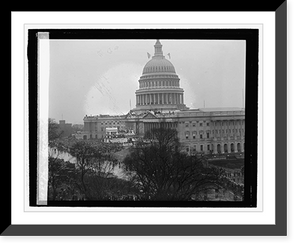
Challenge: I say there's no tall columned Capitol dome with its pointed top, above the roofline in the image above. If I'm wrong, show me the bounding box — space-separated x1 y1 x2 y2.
135 40 186 111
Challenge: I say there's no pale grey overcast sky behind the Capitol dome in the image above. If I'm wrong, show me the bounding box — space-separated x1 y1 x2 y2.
49 40 246 124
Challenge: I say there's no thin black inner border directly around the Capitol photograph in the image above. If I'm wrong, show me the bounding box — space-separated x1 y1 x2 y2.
28 29 259 207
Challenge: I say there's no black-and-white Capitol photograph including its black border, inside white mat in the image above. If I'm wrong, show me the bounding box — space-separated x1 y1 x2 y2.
28 29 258 207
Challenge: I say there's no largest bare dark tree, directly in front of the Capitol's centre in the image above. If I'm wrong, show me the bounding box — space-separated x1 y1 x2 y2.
124 128 224 200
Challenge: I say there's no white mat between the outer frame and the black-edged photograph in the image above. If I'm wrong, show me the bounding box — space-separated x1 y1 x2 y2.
12 12 275 224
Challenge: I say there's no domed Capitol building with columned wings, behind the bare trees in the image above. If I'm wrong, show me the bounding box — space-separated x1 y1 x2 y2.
82 40 245 154
